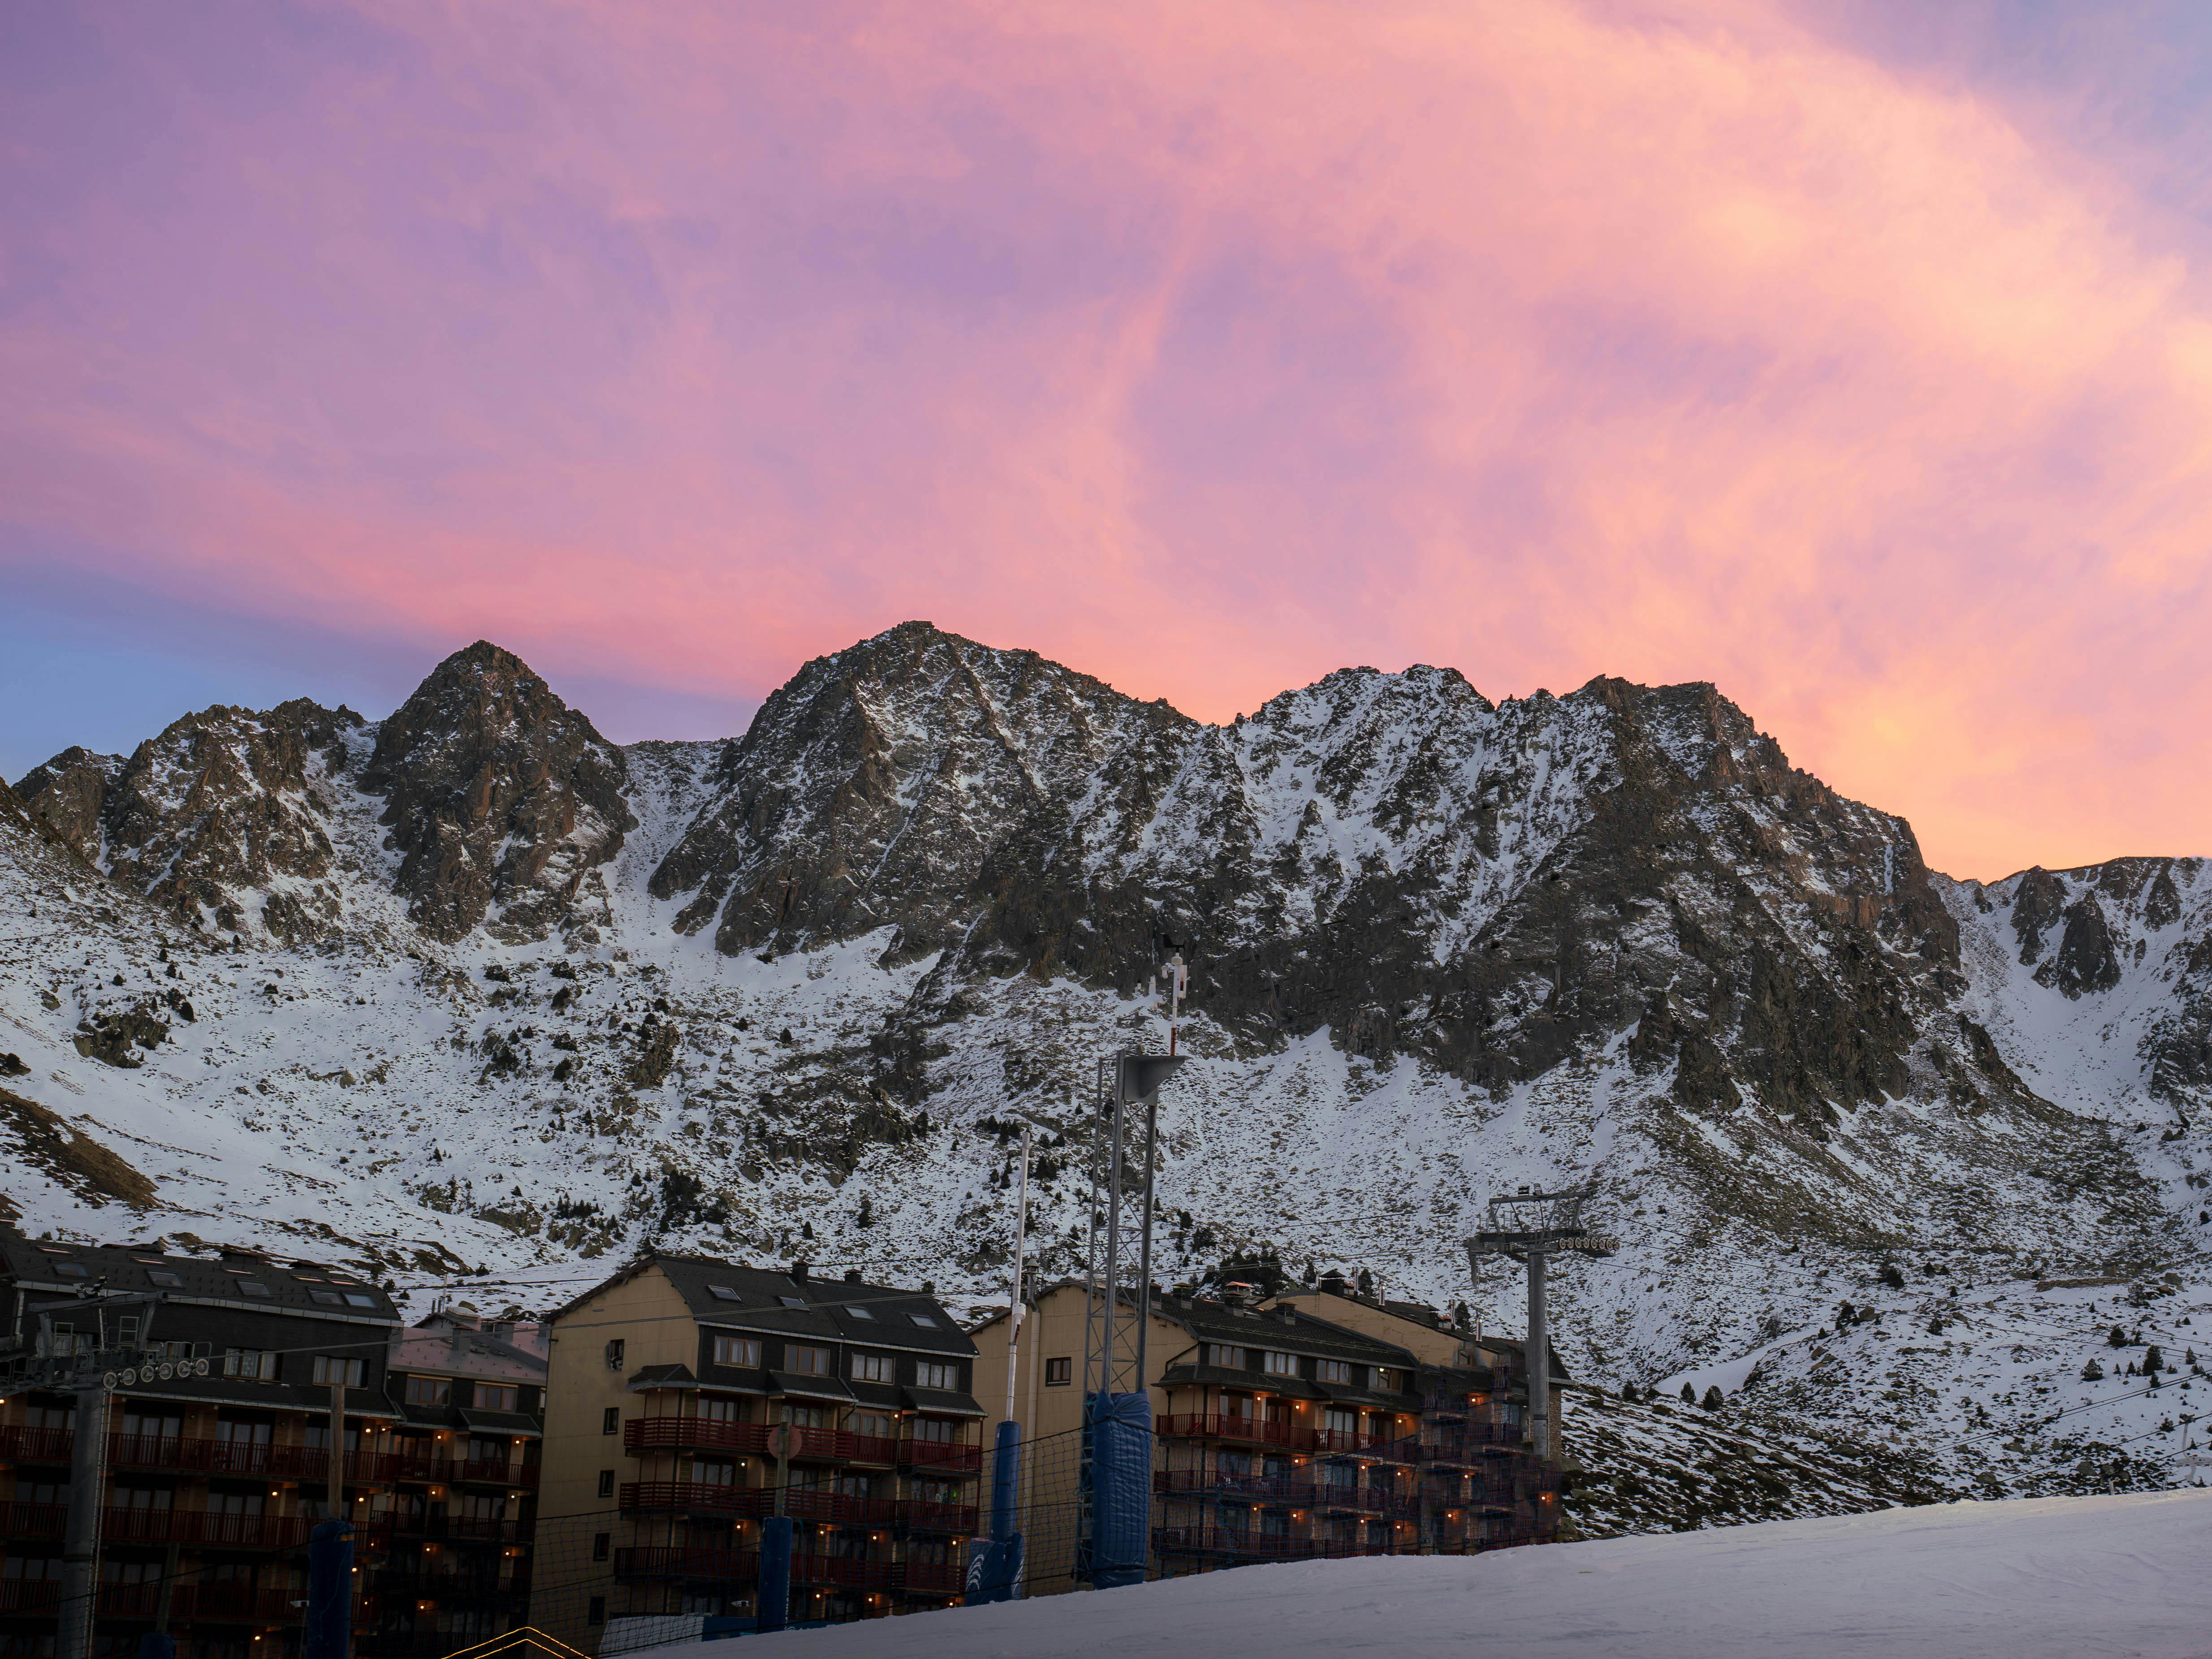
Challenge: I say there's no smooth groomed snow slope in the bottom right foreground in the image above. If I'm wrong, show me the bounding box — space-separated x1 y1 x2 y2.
652 1491 2212 1659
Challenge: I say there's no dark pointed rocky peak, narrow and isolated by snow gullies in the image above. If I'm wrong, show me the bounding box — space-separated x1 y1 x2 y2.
361 639 637 940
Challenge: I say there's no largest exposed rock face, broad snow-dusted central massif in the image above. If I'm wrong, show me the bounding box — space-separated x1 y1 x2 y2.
652 624 1975 1135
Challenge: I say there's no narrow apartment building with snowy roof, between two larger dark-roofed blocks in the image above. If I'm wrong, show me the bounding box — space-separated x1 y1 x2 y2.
376 1303 546 1659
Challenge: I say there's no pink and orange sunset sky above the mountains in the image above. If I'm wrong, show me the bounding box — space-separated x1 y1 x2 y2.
0 0 2212 878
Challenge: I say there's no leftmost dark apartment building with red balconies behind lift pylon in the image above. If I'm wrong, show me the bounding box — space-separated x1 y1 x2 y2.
0 1239 400 1659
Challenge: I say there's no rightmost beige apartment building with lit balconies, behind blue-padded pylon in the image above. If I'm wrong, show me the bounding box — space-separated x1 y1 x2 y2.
973 1281 1564 1595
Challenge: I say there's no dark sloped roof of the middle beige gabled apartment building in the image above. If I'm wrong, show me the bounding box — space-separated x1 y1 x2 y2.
553 1257 976 1358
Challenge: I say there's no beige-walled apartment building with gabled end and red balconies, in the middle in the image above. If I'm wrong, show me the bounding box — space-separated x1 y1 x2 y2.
533 1254 982 1652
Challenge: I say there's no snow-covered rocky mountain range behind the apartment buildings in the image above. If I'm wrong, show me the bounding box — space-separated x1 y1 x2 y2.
0 624 2212 1521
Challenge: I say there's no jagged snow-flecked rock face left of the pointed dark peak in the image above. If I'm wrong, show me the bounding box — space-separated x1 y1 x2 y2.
24 697 361 940
